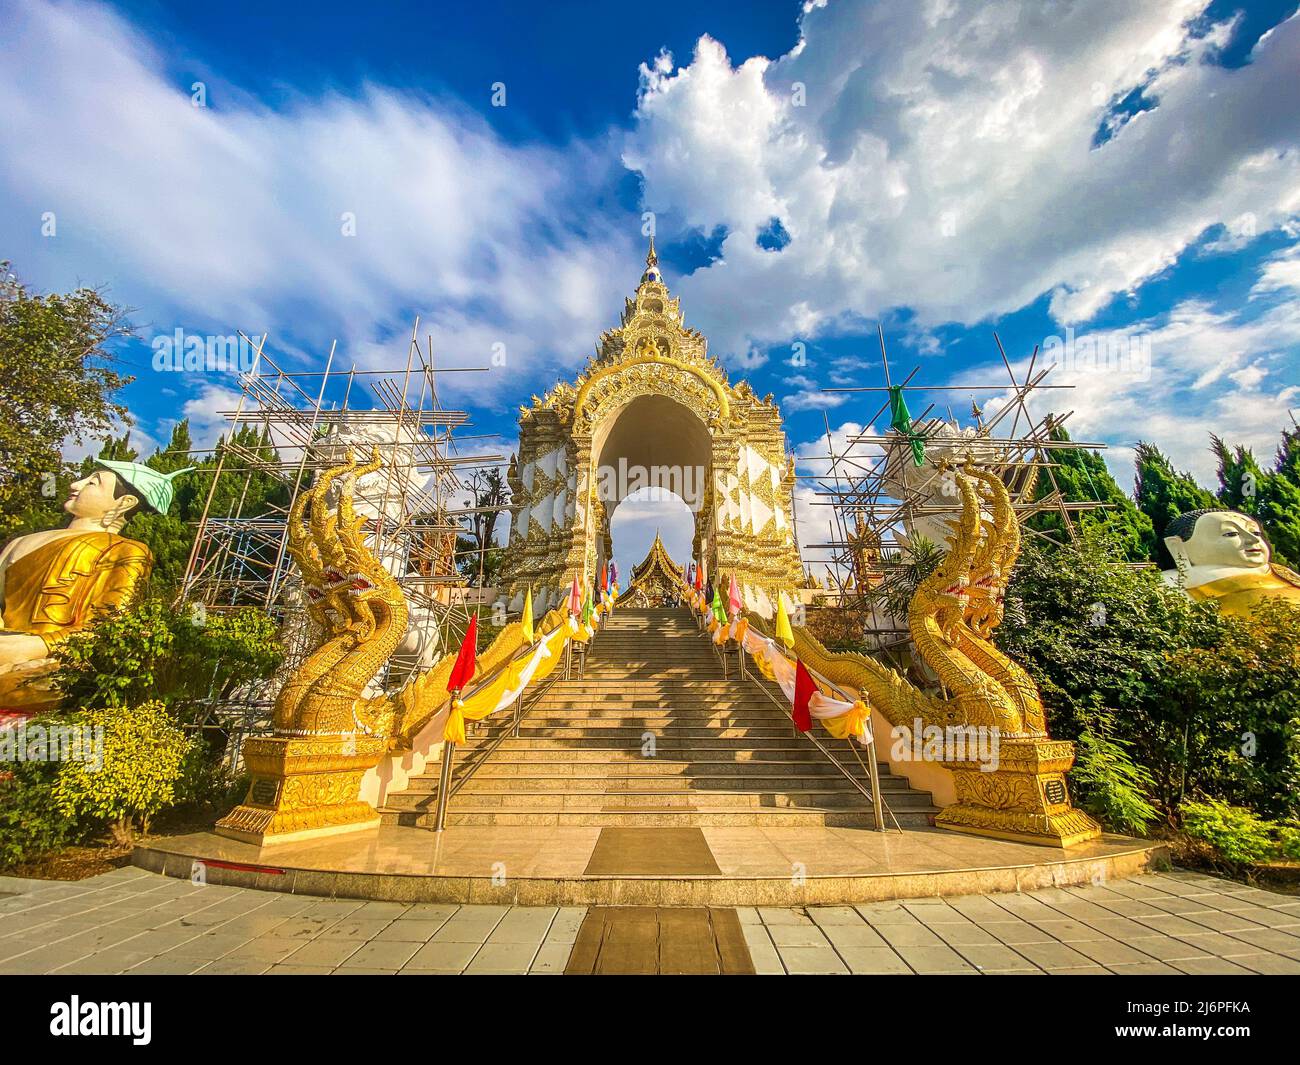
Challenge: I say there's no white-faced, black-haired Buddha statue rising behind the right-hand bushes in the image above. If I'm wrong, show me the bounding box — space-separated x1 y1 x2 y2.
1165 510 1300 616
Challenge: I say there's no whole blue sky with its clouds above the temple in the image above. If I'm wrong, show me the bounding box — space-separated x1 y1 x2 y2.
0 0 1300 579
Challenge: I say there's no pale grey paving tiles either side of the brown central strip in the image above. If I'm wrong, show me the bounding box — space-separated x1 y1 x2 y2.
0 869 1300 975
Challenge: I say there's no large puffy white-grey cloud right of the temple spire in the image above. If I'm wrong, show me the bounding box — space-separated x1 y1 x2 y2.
624 0 1300 352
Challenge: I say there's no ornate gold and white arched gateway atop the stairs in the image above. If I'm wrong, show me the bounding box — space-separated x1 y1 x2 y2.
503 243 801 616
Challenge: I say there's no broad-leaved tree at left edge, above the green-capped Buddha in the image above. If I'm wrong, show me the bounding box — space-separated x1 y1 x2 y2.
0 261 131 541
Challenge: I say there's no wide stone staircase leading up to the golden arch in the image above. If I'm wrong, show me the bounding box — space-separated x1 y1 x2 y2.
380 607 937 827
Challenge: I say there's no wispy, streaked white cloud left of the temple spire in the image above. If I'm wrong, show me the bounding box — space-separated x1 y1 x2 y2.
0 0 638 408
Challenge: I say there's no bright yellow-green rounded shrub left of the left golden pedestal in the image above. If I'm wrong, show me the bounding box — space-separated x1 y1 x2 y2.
55 701 192 843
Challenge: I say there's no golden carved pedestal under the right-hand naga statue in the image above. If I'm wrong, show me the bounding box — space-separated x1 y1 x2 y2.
935 739 1101 847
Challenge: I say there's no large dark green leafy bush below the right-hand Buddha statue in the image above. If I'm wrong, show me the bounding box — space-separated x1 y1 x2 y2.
997 529 1300 818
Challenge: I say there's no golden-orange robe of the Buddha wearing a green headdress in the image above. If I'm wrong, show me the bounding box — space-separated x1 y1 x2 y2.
0 532 153 710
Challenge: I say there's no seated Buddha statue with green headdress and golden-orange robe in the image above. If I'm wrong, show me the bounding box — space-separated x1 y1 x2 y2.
0 459 186 714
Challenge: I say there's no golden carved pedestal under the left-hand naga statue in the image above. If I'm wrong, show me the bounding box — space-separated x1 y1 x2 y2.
216 736 387 847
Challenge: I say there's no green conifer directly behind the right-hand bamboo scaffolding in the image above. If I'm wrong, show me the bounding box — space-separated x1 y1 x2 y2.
1030 424 1156 562
